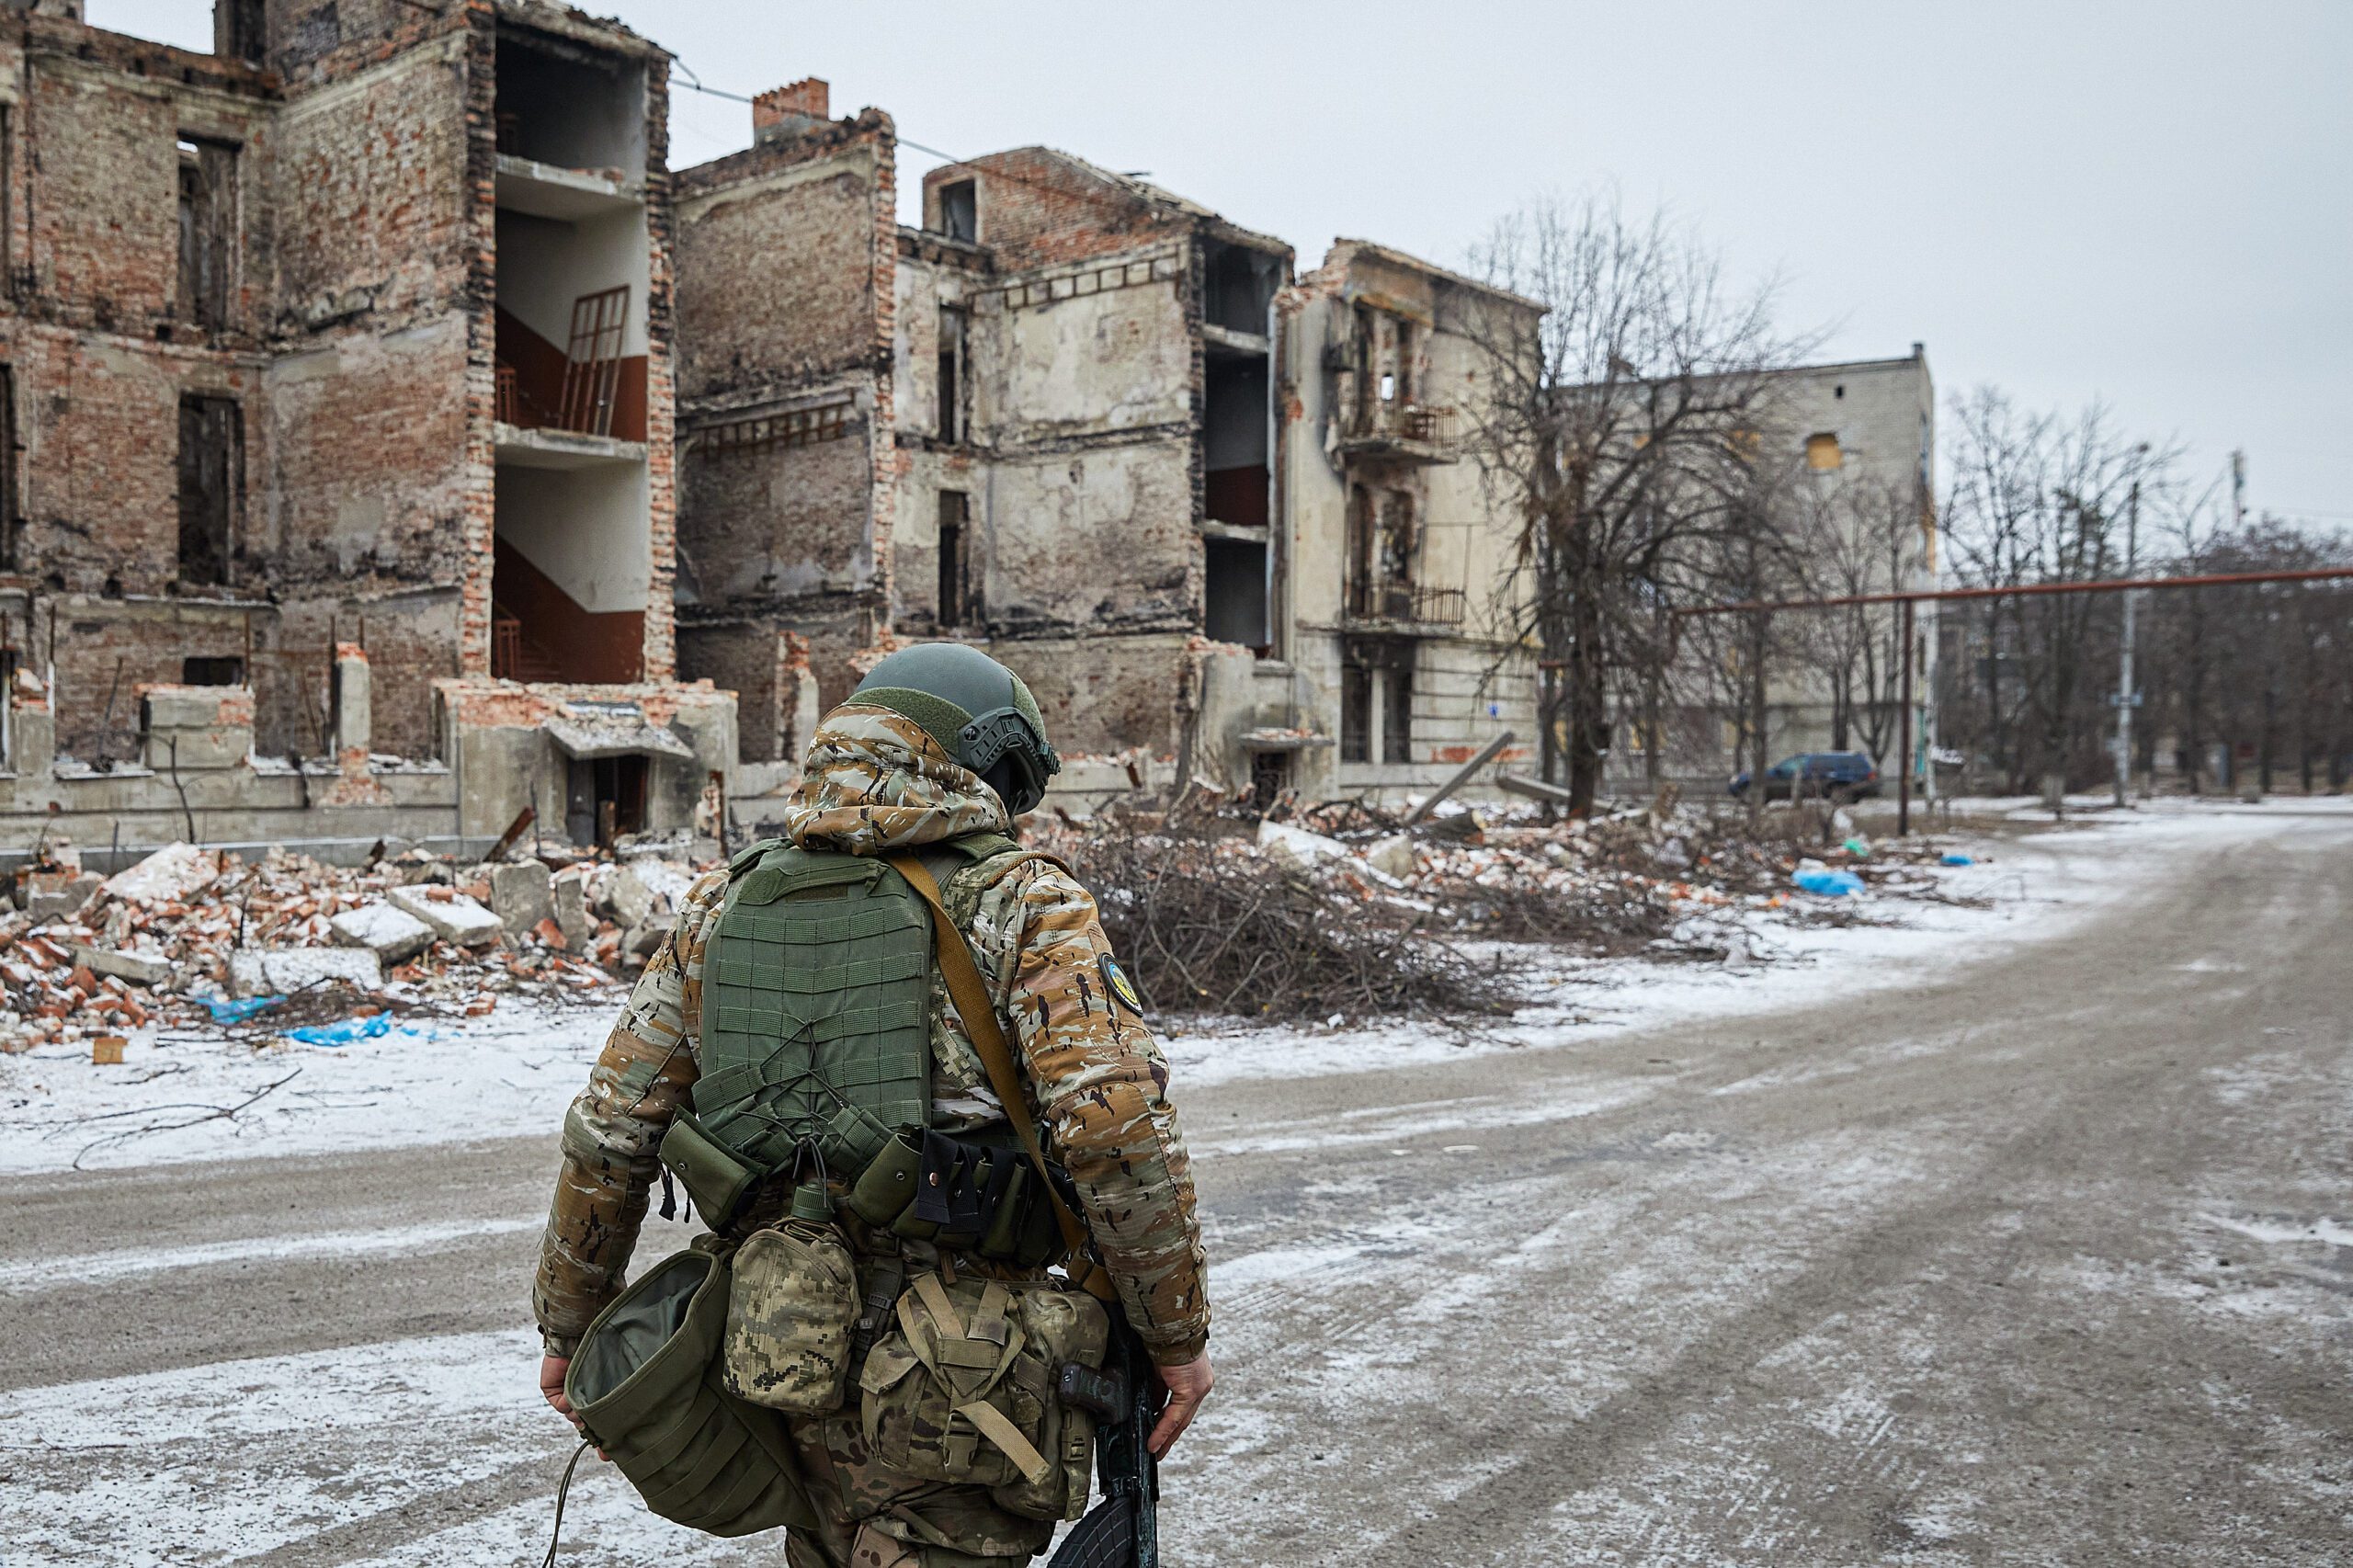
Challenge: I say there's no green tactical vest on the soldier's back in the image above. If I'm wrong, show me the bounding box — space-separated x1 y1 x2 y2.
661 834 1024 1229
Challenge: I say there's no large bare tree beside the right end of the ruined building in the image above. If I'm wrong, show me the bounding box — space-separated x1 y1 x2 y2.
1461 198 1810 810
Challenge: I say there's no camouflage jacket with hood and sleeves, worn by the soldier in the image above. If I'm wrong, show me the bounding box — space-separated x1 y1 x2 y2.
532 706 1210 1363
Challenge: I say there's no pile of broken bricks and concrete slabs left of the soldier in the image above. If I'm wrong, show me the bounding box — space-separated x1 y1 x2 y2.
0 843 715 1050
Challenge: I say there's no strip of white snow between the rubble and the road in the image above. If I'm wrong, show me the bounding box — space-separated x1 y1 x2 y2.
0 801 2353 1175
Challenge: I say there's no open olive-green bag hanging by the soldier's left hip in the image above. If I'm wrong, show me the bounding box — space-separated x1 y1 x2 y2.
564 1236 816 1535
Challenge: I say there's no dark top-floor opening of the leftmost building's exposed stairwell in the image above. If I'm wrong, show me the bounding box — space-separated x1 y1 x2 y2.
494 28 644 184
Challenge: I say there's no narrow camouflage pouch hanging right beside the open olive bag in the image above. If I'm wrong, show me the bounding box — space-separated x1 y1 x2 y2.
722 1220 858 1415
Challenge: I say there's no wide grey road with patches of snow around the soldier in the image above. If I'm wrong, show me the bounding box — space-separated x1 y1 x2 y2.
0 802 2353 1568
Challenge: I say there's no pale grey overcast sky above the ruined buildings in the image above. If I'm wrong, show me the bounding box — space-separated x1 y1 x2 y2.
89 0 2353 525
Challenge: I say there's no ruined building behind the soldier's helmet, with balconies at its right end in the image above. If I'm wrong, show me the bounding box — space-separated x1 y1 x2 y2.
677 80 1532 814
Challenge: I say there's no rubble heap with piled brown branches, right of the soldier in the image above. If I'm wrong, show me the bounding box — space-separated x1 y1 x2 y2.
1033 802 1976 1017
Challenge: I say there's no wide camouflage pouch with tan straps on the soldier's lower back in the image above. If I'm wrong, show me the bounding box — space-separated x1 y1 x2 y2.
858 1274 1110 1518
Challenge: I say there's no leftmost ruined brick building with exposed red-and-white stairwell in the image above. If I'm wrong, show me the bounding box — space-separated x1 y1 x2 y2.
0 0 736 846
